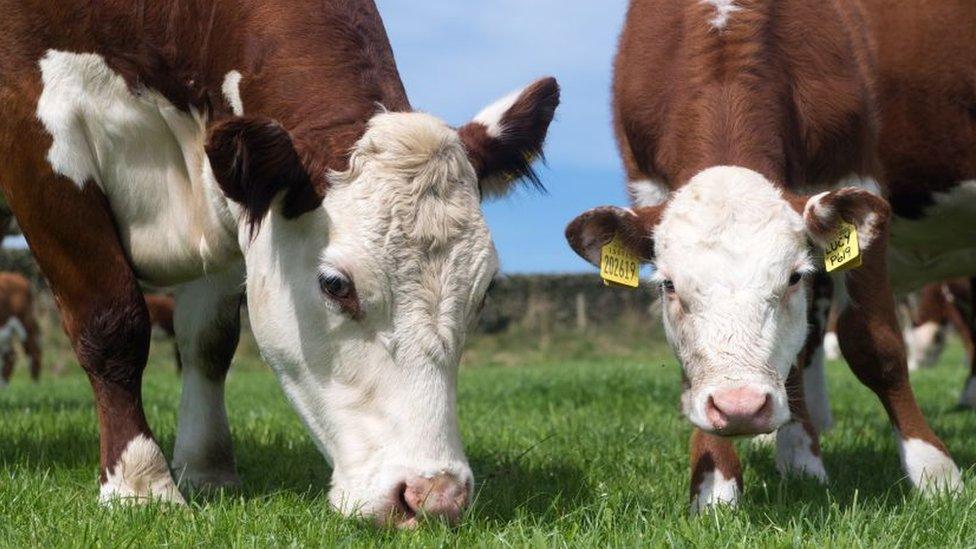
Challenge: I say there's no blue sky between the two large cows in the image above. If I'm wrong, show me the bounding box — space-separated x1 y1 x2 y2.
377 0 626 273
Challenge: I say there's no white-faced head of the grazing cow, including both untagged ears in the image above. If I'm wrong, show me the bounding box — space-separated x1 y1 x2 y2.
207 79 559 526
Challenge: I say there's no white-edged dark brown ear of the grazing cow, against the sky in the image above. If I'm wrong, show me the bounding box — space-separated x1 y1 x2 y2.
458 78 559 198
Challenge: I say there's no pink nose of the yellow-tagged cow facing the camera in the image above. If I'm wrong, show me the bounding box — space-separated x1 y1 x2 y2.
705 386 773 435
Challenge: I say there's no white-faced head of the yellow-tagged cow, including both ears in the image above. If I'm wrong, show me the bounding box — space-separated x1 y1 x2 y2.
566 167 888 435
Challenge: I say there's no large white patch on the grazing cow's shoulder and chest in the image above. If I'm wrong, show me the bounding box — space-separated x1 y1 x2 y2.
37 51 237 285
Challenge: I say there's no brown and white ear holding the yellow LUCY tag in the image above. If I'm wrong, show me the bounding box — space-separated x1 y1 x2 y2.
789 187 891 250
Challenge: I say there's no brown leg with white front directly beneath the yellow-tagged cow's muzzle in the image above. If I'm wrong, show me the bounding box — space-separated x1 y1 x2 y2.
691 428 742 514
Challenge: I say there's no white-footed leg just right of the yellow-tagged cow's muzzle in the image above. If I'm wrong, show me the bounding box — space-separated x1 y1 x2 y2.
776 367 827 482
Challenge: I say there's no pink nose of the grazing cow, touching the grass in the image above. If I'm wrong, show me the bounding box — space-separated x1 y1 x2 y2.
398 473 469 528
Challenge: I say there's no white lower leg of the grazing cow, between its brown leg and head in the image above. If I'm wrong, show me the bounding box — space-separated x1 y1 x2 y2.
173 267 244 489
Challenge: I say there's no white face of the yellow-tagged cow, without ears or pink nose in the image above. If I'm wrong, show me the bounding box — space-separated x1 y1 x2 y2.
654 166 814 431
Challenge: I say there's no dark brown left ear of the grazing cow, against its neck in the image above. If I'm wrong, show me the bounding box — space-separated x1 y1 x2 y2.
206 116 322 235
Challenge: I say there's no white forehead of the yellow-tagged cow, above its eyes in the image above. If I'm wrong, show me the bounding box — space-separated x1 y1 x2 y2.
654 166 808 287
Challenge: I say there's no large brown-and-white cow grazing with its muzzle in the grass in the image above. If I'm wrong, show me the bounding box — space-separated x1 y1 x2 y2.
0 0 559 526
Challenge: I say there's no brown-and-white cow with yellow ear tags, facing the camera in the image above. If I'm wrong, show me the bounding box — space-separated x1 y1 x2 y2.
567 0 976 509
